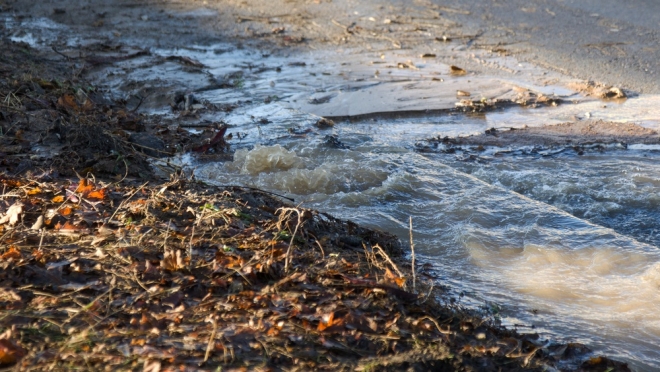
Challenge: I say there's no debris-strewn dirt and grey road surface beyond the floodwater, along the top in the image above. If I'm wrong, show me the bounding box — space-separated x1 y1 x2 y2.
9 0 660 93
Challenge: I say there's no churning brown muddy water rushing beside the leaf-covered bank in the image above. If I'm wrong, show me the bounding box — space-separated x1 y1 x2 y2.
178 47 660 370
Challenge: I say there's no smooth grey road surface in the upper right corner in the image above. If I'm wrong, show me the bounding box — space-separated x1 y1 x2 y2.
434 0 660 93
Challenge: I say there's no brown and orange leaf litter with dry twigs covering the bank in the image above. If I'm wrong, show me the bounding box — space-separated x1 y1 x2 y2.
0 32 628 372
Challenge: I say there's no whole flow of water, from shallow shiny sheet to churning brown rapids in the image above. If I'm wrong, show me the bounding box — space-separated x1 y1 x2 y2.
7 15 660 370
